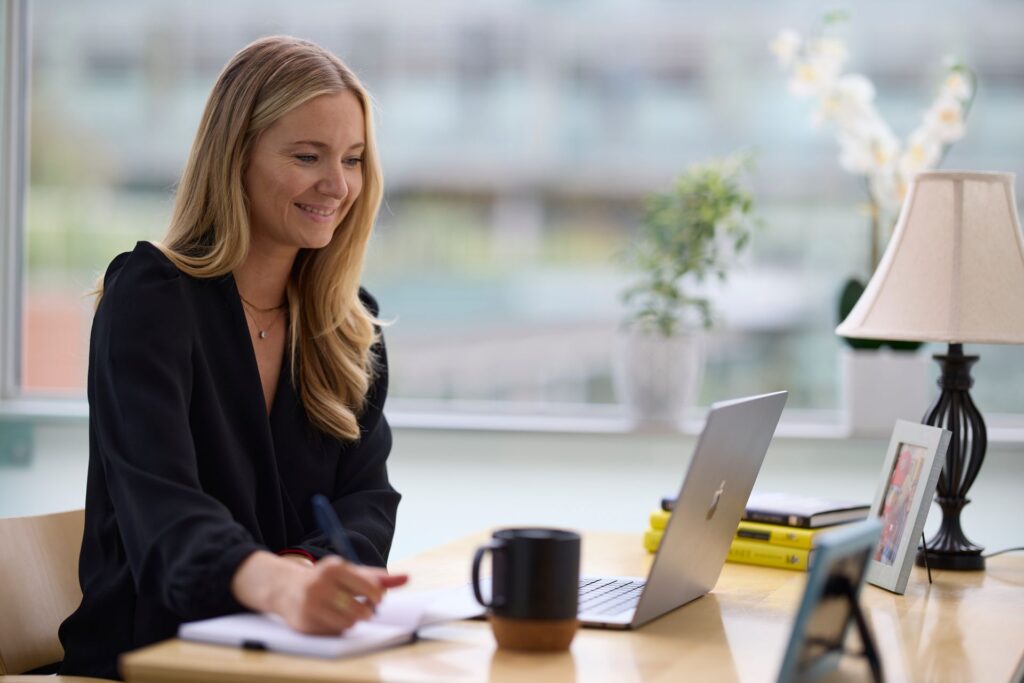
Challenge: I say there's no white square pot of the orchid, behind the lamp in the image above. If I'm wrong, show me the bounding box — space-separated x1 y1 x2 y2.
840 348 939 436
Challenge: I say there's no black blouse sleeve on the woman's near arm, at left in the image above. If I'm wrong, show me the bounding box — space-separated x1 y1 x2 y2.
89 248 261 621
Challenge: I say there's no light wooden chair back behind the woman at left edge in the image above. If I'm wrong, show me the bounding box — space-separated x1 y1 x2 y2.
0 510 112 683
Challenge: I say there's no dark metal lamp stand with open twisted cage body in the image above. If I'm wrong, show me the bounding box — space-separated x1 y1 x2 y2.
916 344 988 570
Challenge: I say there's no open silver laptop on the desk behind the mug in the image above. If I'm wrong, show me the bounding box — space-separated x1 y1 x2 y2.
579 391 788 629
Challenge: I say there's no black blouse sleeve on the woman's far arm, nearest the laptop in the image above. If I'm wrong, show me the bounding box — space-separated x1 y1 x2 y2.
295 291 401 566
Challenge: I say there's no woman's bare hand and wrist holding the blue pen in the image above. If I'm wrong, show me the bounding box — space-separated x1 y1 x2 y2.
231 551 409 635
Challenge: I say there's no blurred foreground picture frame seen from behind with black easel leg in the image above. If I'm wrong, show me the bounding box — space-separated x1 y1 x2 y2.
777 518 883 683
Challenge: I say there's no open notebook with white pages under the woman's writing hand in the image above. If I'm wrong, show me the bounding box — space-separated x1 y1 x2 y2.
178 586 482 658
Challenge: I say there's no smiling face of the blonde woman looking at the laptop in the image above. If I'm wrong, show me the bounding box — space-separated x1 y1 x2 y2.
242 91 366 255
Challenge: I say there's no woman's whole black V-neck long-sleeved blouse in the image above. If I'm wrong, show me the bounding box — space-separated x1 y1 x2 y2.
59 242 400 678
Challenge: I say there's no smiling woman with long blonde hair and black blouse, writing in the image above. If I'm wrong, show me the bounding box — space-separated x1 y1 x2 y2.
60 37 406 677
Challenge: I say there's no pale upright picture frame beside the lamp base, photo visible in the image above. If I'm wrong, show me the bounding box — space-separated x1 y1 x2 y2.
867 420 950 595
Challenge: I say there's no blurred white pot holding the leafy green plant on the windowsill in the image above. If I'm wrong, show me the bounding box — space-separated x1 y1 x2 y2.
614 331 705 426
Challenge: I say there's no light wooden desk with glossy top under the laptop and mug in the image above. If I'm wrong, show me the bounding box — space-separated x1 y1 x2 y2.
122 533 1024 683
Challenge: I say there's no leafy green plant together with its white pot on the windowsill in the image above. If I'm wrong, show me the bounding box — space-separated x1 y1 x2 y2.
615 154 754 424
